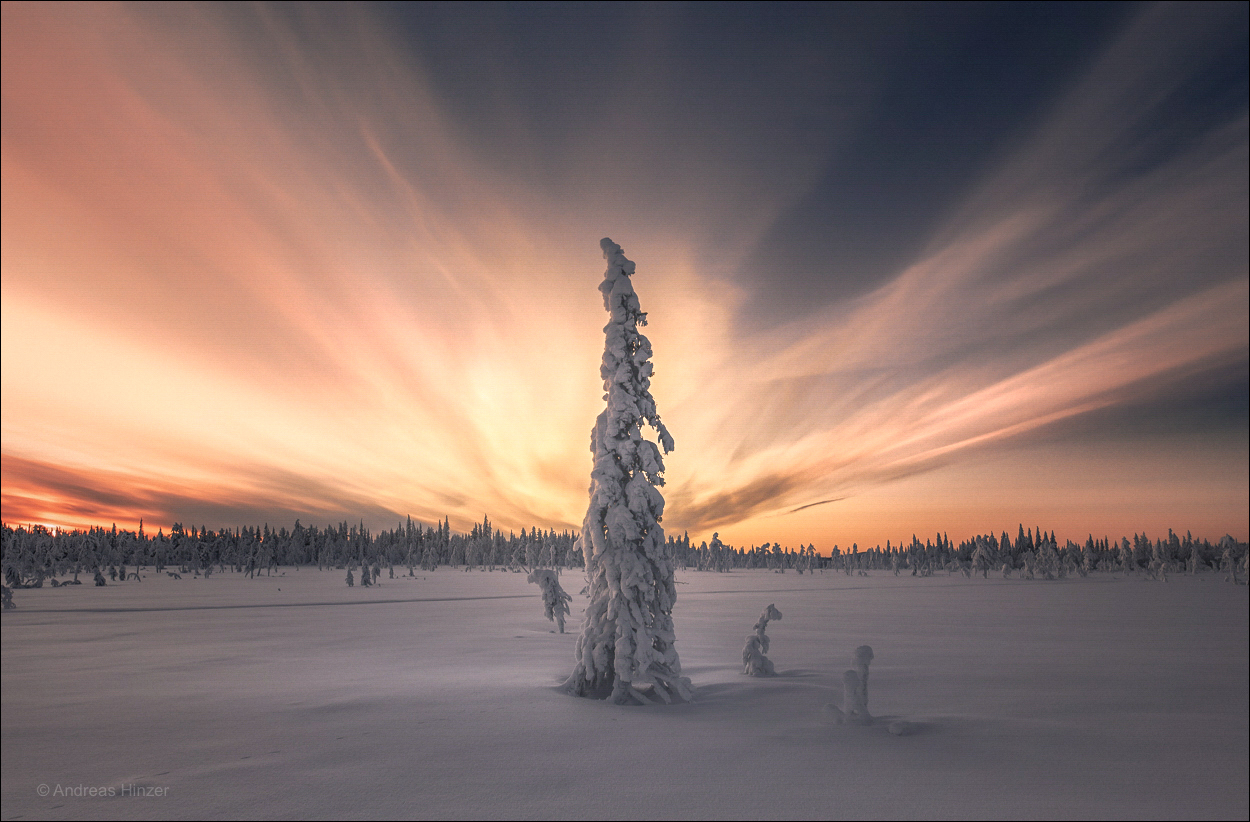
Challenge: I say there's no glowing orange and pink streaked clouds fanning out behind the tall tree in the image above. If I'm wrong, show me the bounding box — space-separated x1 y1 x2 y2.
0 4 1248 550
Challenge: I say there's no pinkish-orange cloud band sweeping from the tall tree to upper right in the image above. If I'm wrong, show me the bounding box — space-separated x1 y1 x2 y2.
658 7 1250 537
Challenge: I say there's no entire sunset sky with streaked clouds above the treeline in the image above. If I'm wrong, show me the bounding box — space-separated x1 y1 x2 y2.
0 2 1250 553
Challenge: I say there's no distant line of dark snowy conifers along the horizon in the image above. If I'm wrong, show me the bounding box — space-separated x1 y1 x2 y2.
0 518 1248 587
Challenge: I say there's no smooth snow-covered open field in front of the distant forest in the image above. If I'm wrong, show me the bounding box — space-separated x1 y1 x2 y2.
0 568 1250 820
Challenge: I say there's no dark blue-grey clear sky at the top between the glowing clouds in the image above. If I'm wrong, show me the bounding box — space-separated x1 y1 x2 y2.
385 2 1248 324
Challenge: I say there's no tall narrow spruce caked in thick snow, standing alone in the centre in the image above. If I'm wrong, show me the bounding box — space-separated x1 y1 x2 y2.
565 237 694 705
